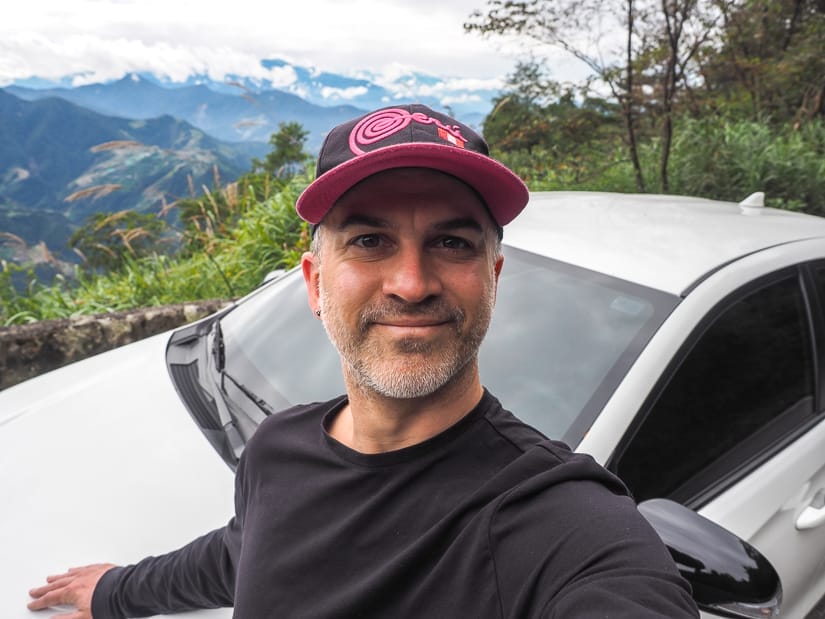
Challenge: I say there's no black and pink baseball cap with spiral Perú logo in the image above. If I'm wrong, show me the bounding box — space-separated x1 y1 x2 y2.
295 104 528 226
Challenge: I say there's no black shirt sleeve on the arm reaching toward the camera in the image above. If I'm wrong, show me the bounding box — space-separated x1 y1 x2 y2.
490 460 699 619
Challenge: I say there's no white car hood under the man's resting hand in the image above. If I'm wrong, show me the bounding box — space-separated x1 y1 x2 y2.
0 334 233 618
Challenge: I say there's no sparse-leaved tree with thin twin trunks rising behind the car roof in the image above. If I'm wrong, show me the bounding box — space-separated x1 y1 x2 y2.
464 0 734 191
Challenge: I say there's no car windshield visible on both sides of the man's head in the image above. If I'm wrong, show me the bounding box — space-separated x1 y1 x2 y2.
221 248 678 447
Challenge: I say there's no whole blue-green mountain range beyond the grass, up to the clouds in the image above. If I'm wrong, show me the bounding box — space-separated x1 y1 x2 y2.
0 60 497 274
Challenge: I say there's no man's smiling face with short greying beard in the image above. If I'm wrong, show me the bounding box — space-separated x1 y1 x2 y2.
304 168 502 398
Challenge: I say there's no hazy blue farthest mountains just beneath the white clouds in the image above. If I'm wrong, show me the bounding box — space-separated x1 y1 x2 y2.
6 59 498 152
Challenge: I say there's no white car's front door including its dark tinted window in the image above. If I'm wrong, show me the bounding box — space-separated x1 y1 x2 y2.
608 263 825 618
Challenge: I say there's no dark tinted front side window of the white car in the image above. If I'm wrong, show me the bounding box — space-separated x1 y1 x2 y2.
610 270 815 504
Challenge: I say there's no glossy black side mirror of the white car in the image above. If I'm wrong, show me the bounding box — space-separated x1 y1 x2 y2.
639 499 782 619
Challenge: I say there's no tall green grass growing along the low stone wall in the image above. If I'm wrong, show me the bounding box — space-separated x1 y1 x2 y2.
0 177 309 326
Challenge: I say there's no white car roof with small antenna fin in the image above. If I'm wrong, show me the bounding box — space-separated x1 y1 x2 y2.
504 191 825 295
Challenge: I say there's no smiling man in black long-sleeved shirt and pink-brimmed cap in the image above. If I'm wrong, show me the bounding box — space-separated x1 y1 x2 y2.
30 105 697 619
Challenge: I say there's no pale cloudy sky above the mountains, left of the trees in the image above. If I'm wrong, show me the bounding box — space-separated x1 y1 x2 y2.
0 0 568 86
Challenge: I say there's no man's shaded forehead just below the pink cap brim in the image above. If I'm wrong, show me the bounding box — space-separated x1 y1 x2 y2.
322 168 493 225
